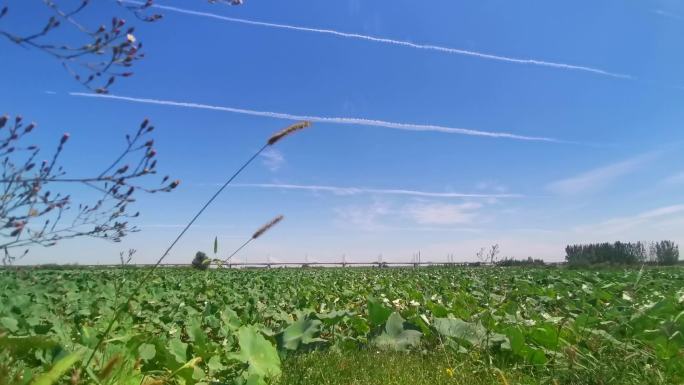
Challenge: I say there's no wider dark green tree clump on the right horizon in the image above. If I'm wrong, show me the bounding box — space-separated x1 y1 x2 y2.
565 242 647 265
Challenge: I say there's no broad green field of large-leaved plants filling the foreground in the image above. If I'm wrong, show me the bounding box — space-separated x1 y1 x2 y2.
0 268 684 385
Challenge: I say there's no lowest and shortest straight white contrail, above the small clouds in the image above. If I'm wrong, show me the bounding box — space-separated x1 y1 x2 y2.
234 183 523 198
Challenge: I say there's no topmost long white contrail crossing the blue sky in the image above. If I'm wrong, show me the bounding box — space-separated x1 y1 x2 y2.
123 0 634 79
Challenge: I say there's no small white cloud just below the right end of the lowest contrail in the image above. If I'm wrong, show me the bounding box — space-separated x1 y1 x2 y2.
403 202 483 225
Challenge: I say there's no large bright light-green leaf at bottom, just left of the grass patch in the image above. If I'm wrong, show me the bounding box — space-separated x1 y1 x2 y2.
231 326 280 378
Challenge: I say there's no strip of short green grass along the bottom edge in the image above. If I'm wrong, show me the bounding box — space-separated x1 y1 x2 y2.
276 350 669 385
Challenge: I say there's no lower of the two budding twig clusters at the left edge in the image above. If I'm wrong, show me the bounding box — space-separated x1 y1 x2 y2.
0 116 179 264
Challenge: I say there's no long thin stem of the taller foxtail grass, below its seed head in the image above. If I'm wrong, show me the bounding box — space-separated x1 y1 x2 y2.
83 143 269 368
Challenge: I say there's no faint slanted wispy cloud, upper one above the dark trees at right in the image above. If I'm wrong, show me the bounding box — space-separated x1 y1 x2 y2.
547 153 654 195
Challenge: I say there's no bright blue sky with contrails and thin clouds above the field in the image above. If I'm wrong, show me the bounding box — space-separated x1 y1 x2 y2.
0 0 684 263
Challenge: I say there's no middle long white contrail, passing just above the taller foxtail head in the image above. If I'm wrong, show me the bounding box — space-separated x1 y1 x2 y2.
69 92 570 143
